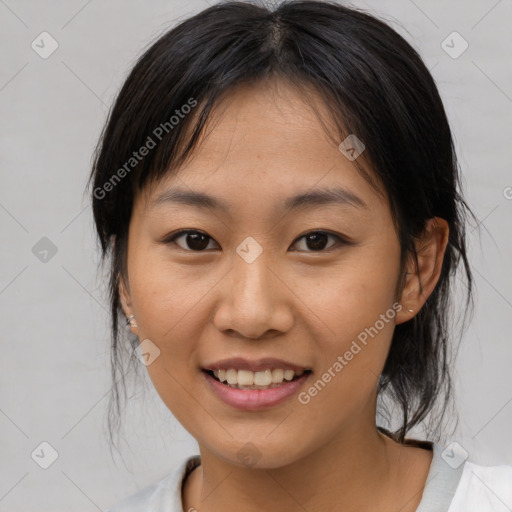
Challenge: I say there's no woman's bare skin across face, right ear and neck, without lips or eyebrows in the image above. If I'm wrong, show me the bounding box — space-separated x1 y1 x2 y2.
119 82 448 512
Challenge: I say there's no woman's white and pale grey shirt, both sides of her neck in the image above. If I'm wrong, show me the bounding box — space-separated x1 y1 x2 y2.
107 443 512 512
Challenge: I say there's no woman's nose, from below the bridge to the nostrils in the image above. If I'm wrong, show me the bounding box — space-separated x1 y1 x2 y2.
213 255 293 339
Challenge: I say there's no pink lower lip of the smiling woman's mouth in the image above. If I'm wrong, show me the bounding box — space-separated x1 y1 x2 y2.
202 371 311 411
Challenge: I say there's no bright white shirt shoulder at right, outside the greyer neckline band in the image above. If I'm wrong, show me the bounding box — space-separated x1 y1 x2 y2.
448 461 512 512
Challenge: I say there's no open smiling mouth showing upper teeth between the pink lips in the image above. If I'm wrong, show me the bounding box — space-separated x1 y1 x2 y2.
203 368 312 390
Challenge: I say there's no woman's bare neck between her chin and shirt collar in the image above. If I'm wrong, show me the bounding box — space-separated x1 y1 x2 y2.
183 426 431 512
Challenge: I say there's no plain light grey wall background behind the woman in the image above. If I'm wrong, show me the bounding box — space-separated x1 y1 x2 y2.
0 0 512 512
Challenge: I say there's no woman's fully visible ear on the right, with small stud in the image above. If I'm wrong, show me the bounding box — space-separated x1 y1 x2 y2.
396 217 450 325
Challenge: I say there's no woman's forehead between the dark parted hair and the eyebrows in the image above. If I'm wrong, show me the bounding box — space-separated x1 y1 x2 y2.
138 82 382 213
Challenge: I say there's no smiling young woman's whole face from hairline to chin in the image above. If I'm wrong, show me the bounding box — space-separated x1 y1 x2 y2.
120 79 416 468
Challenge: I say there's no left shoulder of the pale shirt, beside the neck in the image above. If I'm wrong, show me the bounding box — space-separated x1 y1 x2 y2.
107 455 200 512
